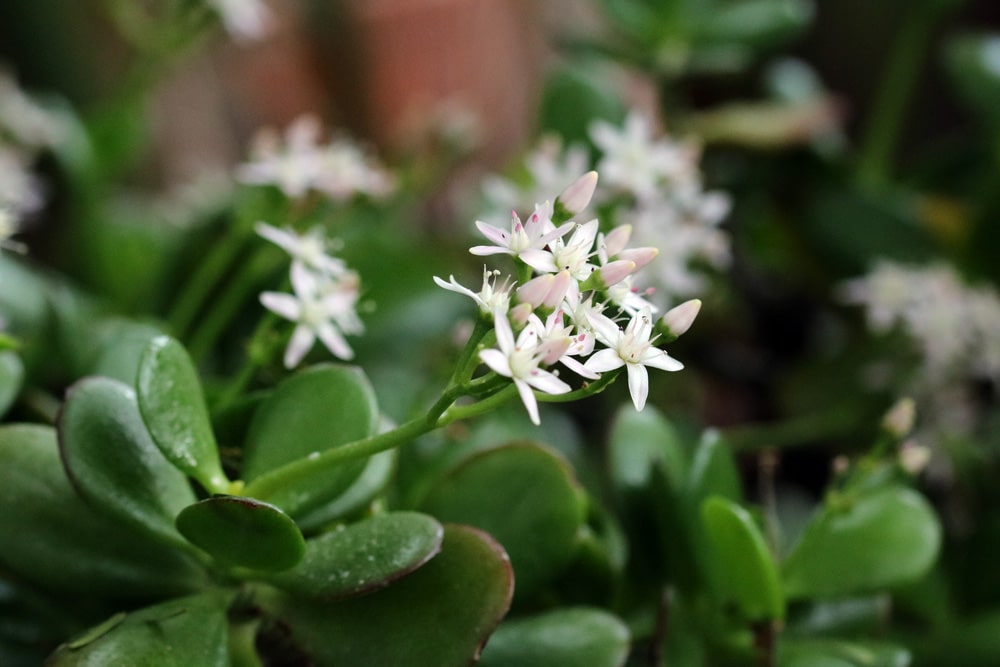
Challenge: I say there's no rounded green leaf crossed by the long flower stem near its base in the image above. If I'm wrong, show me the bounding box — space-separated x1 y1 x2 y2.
243 365 379 517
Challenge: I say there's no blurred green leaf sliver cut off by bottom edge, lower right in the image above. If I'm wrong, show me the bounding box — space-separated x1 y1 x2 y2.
778 639 911 667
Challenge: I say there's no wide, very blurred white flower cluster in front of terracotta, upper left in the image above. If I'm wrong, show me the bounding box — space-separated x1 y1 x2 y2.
236 114 394 201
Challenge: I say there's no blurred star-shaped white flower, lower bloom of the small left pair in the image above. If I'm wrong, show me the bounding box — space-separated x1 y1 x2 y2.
260 263 364 368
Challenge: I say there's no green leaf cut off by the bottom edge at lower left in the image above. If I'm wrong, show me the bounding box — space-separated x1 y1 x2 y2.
46 592 230 667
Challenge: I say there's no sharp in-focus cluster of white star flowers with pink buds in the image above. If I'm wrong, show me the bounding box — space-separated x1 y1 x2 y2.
434 172 700 424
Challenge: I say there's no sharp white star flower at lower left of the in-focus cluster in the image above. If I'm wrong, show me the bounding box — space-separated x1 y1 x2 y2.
479 313 570 426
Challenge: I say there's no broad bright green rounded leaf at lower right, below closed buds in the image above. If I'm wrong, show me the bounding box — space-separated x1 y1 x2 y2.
783 487 941 598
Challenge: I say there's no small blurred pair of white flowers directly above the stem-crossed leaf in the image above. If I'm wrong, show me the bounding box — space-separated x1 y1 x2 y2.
256 223 364 368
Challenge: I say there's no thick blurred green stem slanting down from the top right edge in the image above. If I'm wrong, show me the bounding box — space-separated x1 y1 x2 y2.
858 2 949 186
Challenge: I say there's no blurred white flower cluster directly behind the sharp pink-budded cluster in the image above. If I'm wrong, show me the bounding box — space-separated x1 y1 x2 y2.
483 111 730 301
